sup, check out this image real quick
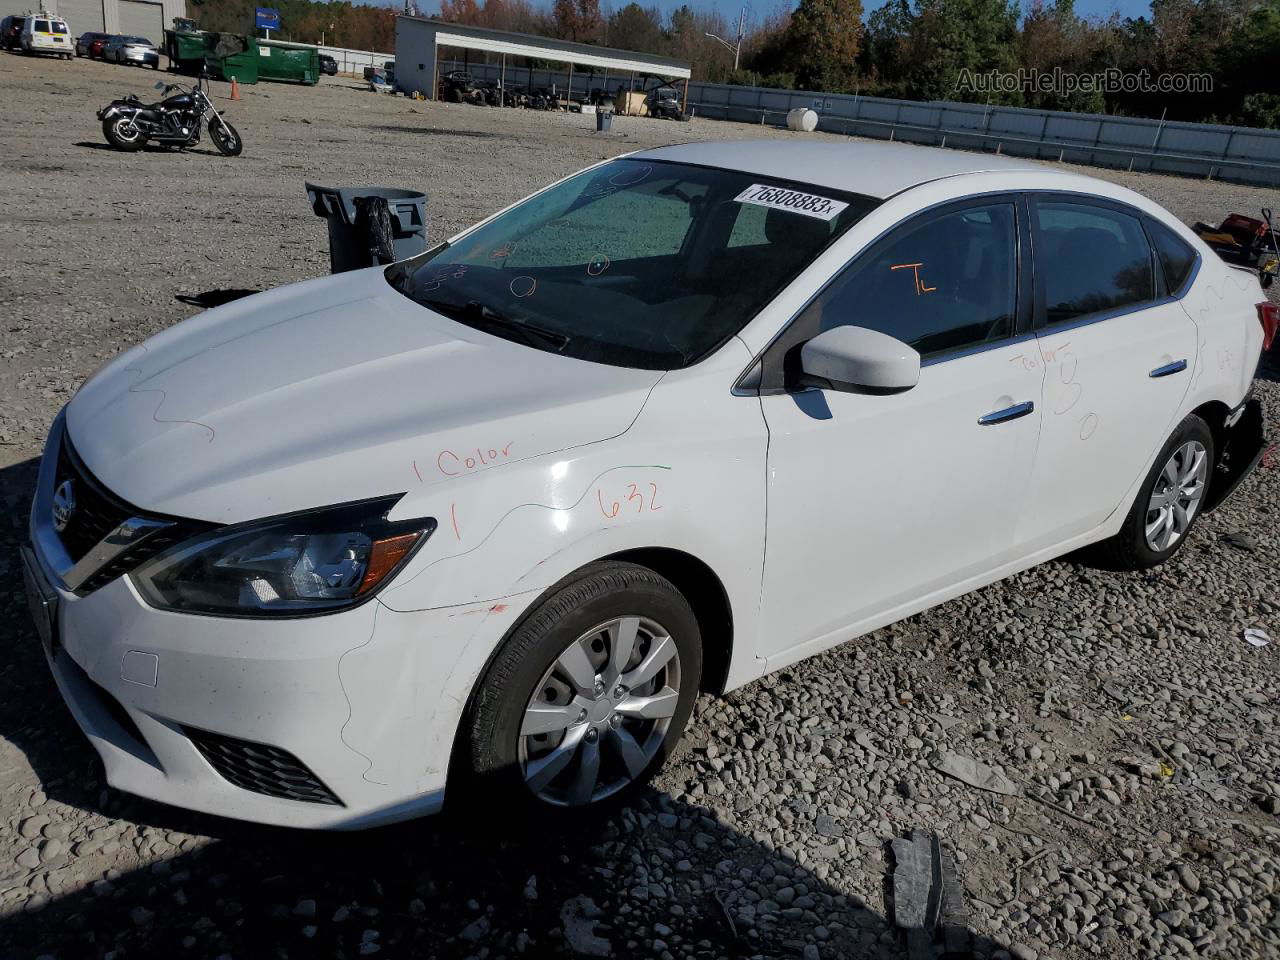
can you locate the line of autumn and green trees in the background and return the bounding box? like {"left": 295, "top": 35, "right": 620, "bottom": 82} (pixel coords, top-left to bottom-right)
{"left": 186, "top": 0, "right": 1280, "bottom": 127}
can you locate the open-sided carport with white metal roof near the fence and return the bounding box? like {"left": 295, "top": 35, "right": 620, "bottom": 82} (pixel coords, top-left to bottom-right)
{"left": 396, "top": 15, "right": 692, "bottom": 102}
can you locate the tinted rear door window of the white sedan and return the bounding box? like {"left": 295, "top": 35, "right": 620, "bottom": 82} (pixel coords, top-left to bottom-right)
{"left": 1036, "top": 201, "right": 1155, "bottom": 324}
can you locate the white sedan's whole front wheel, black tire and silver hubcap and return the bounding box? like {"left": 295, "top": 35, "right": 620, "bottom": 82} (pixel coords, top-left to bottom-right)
{"left": 462, "top": 563, "right": 701, "bottom": 822}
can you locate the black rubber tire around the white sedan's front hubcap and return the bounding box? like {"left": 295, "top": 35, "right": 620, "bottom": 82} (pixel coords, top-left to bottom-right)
{"left": 451, "top": 562, "right": 701, "bottom": 824}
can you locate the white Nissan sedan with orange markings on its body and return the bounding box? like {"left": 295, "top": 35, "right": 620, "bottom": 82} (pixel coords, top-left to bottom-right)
{"left": 24, "top": 141, "right": 1276, "bottom": 827}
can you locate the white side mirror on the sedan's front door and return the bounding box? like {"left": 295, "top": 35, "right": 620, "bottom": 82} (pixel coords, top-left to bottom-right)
{"left": 800, "top": 326, "right": 920, "bottom": 393}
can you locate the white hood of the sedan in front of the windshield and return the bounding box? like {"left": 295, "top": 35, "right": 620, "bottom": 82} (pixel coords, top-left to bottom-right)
{"left": 67, "top": 269, "right": 662, "bottom": 522}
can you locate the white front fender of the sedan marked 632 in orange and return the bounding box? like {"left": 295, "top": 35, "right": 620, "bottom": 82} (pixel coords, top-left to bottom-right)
{"left": 380, "top": 344, "right": 767, "bottom": 691}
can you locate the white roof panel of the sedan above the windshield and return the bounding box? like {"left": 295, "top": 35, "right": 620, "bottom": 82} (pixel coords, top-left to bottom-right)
{"left": 632, "top": 140, "right": 1046, "bottom": 200}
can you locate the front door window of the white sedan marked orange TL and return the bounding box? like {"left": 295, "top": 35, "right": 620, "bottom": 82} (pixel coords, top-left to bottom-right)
{"left": 810, "top": 204, "right": 1018, "bottom": 357}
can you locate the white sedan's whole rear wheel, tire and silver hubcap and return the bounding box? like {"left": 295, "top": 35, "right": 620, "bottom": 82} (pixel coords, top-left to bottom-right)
{"left": 1100, "top": 416, "right": 1215, "bottom": 570}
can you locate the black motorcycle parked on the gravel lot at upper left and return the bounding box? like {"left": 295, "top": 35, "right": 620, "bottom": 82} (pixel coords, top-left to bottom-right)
{"left": 97, "top": 73, "right": 244, "bottom": 156}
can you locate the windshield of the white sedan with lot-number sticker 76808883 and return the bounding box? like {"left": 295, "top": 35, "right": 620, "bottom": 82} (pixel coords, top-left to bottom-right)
{"left": 387, "top": 160, "right": 878, "bottom": 370}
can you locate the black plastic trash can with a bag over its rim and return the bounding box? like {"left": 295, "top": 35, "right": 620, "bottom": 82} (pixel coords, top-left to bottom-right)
{"left": 306, "top": 183, "right": 426, "bottom": 274}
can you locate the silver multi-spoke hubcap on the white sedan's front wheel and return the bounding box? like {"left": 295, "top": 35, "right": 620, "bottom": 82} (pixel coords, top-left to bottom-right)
{"left": 520, "top": 617, "right": 680, "bottom": 806}
